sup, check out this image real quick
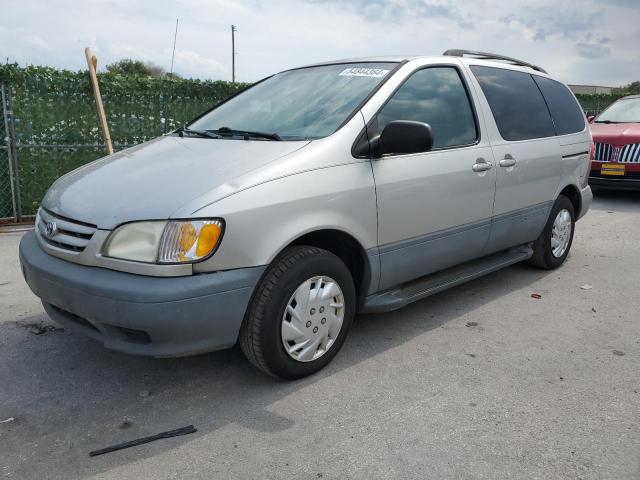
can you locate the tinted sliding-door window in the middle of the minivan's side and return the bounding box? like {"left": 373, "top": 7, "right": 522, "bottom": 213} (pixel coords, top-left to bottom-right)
{"left": 471, "top": 65, "right": 555, "bottom": 141}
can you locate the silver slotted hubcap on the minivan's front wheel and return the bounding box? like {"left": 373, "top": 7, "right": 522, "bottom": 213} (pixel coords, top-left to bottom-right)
{"left": 281, "top": 276, "right": 344, "bottom": 362}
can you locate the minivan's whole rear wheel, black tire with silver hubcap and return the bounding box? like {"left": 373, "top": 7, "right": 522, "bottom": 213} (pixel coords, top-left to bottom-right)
{"left": 529, "top": 195, "right": 576, "bottom": 270}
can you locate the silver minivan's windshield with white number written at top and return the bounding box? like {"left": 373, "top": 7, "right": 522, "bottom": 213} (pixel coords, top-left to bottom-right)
{"left": 189, "top": 63, "right": 396, "bottom": 140}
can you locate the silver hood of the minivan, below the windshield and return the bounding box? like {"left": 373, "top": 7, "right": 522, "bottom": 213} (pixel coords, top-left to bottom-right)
{"left": 42, "top": 136, "right": 309, "bottom": 229}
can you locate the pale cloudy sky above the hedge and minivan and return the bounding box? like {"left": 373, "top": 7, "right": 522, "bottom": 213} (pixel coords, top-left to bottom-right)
{"left": 0, "top": 0, "right": 640, "bottom": 86}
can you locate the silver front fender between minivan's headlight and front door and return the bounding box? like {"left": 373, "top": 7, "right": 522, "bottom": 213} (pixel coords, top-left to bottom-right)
{"left": 194, "top": 161, "right": 377, "bottom": 272}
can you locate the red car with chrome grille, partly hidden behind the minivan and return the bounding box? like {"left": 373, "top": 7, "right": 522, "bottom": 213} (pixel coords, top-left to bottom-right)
{"left": 589, "top": 95, "right": 640, "bottom": 189}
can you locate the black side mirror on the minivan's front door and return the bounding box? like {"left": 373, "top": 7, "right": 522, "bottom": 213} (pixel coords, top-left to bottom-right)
{"left": 374, "top": 120, "right": 433, "bottom": 157}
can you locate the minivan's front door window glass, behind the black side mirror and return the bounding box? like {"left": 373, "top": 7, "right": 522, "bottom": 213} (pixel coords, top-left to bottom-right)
{"left": 378, "top": 67, "right": 477, "bottom": 148}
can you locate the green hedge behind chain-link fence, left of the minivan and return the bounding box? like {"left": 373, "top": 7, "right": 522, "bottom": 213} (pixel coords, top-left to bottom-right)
{"left": 0, "top": 65, "right": 246, "bottom": 217}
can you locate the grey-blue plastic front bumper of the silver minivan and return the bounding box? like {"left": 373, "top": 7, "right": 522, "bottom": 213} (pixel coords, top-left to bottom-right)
{"left": 20, "top": 232, "right": 265, "bottom": 357}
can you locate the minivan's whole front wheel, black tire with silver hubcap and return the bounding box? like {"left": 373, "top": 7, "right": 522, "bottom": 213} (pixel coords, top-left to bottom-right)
{"left": 240, "top": 246, "right": 356, "bottom": 380}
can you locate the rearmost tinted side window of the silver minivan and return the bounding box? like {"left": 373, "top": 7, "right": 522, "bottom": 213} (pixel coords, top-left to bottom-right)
{"left": 533, "top": 75, "right": 585, "bottom": 135}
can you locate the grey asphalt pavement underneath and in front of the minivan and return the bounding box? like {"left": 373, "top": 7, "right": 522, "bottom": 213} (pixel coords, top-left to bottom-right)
{"left": 0, "top": 192, "right": 640, "bottom": 480}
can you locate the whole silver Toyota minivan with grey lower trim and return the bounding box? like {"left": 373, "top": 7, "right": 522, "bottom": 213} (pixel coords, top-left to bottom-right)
{"left": 20, "top": 50, "right": 592, "bottom": 379}
